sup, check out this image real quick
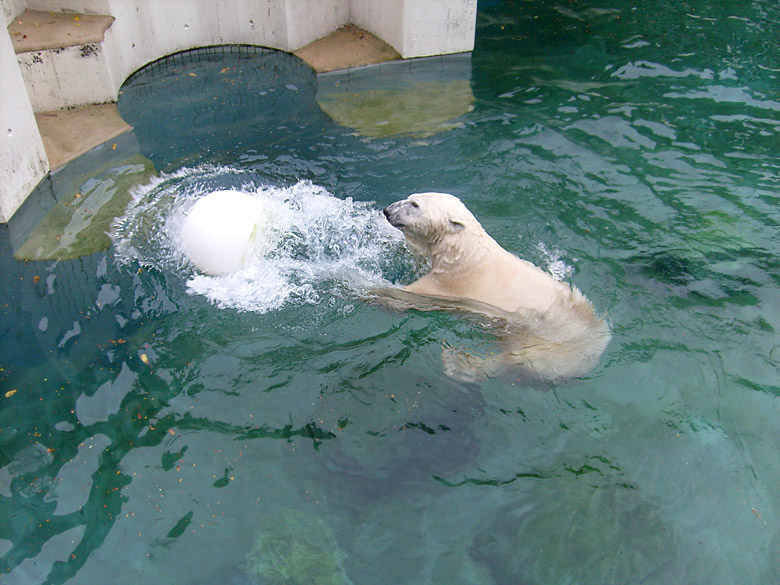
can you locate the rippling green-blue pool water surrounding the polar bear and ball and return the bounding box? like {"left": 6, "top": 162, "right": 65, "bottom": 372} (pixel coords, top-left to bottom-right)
{"left": 0, "top": 1, "right": 780, "bottom": 585}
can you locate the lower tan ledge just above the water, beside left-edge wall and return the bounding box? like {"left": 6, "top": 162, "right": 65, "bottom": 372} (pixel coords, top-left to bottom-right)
{"left": 35, "top": 104, "right": 132, "bottom": 171}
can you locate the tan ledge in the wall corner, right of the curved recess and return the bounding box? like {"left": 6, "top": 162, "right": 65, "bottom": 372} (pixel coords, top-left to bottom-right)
{"left": 293, "top": 24, "right": 401, "bottom": 73}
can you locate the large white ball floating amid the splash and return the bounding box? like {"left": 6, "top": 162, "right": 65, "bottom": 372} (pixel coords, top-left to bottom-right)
{"left": 181, "top": 191, "right": 266, "bottom": 276}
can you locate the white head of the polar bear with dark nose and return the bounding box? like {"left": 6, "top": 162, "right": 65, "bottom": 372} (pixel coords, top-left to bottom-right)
{"left": 384, "top": 193, "right": 486, "bottom": 254}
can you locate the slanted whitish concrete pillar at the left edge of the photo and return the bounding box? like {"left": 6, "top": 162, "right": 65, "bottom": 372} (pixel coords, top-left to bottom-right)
{"left": 0, "top": 27, "right": 49, "bottom": 223}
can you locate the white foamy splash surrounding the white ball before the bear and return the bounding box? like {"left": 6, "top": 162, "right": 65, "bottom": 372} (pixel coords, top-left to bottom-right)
{"left": 112, "top": 167, "right": 416, "bottom": 313}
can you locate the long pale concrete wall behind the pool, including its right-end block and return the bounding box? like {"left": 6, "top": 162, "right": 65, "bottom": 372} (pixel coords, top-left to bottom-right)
{"left": 18, "top": 0, "right": 477, "bottom": 110}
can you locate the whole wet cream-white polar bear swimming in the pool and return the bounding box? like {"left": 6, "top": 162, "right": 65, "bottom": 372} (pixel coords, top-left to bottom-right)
{"left": 384, "top": 193, "right": 611, "bottom": 383}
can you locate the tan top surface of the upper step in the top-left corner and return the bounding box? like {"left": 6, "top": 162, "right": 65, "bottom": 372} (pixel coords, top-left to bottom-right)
{"left": 8, "top": 10, "right": 114, "bottom": 54}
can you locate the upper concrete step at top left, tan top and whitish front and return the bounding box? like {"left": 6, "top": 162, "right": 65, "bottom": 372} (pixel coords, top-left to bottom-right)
{"left": 8, "top": 10, "right": 116, "bottom": 112}
